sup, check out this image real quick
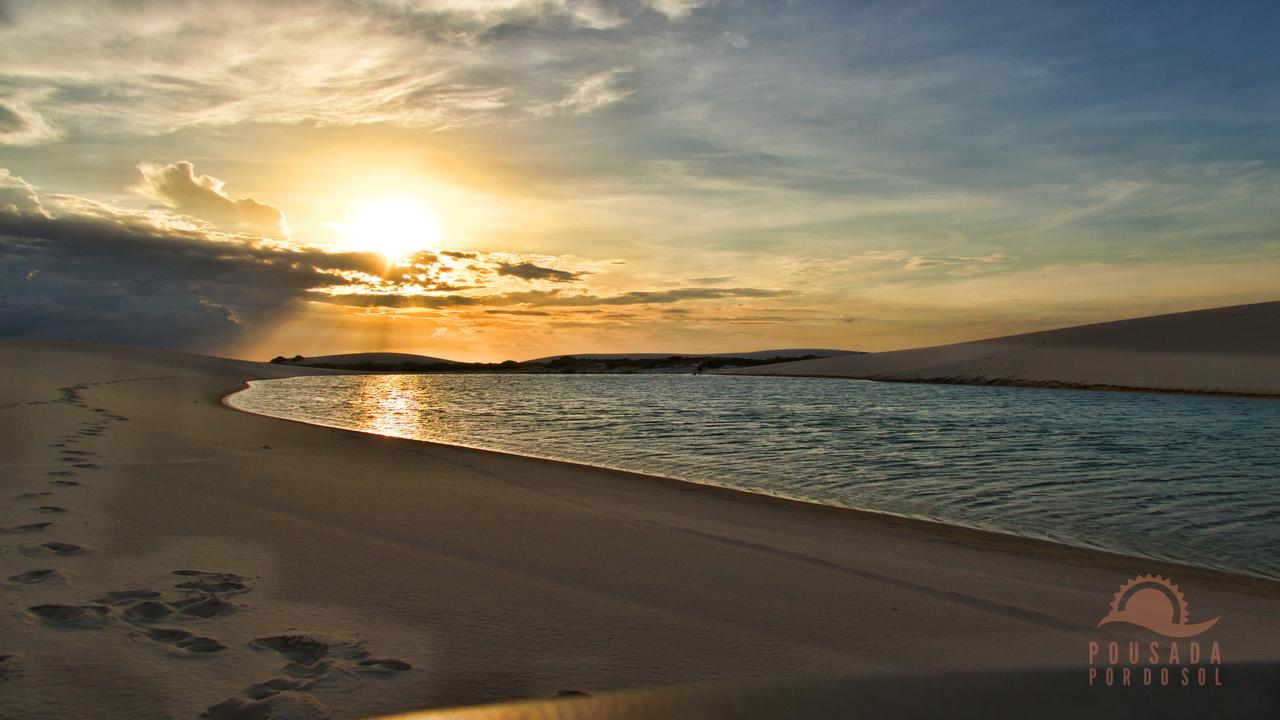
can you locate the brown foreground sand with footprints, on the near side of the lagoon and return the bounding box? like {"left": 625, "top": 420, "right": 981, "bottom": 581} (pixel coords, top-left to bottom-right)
{"left": 0, "top": 342, "right": 1280, "bottom": 719}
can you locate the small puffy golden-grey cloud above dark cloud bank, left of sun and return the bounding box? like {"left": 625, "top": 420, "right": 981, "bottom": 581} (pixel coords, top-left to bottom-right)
{"left": 131, "top": 160, "right": 288, "bottom": 237}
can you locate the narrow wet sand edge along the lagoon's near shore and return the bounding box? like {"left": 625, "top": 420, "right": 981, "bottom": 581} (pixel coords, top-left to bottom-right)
{"left": 220, "top": 381, "right": 1280, "bottom": 589}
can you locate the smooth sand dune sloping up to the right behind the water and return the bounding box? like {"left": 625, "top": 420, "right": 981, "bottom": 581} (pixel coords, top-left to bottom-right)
{"left": 724, "top": 302, "right": 1280, "bottom": 395}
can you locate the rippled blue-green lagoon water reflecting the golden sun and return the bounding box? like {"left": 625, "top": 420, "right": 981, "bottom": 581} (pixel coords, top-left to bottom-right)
{"left": 230, "top": 375, "right": 1280, "bottom": 578}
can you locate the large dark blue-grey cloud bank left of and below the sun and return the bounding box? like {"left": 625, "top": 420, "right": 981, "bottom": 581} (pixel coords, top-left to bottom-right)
{"left": 0, "top": 181, "right": 383, "bottom": 348}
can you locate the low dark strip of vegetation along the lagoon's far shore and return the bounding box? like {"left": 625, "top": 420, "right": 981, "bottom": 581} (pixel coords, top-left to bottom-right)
{"left": 271, "top": 355, "right": 820, "bottom": 375}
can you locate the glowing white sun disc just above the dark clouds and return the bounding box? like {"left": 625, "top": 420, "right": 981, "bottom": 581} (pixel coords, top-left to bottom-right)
{"left": 333, "top": 197, "right": 440, "bottom": 264}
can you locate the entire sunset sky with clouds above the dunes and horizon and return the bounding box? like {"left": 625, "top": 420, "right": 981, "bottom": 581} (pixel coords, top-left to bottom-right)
{"left": 0, "top": 0, "right": 1280, "bottom": 361}
